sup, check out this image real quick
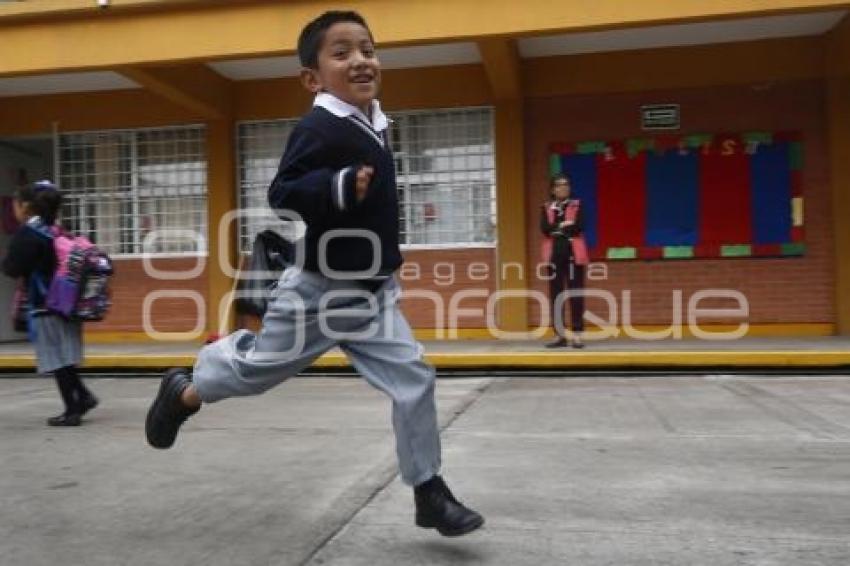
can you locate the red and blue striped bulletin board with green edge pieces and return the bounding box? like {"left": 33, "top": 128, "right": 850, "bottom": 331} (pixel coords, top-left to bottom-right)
{"left": 549, "top": 132, "right": 805, "bottom": 260}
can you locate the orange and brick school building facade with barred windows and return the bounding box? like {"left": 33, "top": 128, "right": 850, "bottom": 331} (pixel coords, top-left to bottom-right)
{"left": 0, "top": 0, "right": 850, "bottom": 340}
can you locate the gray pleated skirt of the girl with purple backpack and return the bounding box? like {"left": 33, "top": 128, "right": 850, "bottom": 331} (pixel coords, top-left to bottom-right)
{"left": 31, "top": 314, "right": 83, "bottom": 373}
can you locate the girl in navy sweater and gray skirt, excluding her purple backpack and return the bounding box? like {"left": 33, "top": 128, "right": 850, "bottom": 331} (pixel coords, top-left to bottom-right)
{"left": 3, "top": 181, "right": 98, "bottom": 426}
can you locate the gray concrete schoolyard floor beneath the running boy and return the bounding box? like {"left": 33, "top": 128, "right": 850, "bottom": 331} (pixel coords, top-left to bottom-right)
{"left": 0, "top": 376, "right": 850, "bottom": 566}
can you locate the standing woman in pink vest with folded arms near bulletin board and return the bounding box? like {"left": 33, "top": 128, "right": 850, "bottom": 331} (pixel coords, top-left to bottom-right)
{"left": 540, "top": 175, "right": 588, "bottom": 348}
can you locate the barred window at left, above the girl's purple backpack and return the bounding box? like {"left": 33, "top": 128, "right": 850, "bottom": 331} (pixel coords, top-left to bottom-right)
{"left": 59, "top": 126, "right": 207, "bottom": 255}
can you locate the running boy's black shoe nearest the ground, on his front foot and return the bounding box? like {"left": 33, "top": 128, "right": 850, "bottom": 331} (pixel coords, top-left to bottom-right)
{"left": 413, "top": 476, "right": 484, "bottom": 537}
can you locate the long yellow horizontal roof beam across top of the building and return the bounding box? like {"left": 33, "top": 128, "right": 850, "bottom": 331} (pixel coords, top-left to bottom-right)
{"left": 0, "top": 0, "right": 850, "bottom": 76}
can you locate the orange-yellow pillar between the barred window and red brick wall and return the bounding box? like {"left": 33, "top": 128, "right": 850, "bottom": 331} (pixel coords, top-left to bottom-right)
{"left": 494, "top": 99, "right": 528, "bottom": 332}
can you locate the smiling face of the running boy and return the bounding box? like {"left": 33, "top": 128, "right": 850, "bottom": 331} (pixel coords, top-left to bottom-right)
{"left": 301, "top": 22, "right": 381, "bottom": 112}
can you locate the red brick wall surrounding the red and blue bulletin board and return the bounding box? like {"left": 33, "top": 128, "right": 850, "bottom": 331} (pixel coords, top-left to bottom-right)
{"left": 526, "top": 82, "right": 835, "bottom": 324}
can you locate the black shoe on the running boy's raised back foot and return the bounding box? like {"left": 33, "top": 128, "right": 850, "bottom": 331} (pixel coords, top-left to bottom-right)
{"left": 145, "top": 368, "right": 198, "bottom": 448}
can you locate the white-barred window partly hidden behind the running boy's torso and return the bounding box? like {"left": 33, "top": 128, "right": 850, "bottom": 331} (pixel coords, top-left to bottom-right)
{"left": 239, "top": 108, "right": 496, "bottom": 252}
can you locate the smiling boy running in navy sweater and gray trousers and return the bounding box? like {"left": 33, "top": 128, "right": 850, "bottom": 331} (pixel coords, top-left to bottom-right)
{"left": 145, "top": 12, "right": 484, "bottom": 536}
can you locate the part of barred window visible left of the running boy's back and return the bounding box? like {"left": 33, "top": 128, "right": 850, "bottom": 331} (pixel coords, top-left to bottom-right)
{"left": 238, "top": 120, "right": 304, "bottom": 252}
